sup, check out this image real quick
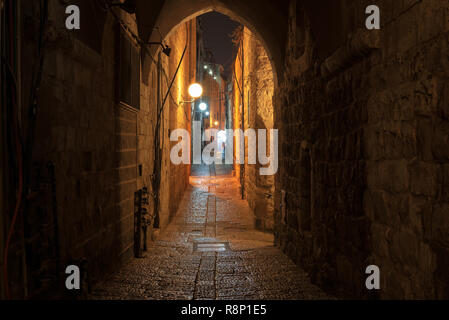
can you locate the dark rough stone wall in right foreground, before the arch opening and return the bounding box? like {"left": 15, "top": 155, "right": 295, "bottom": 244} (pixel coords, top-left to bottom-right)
{"left": 275, "top": 0, "right": 449, "bottom": 298}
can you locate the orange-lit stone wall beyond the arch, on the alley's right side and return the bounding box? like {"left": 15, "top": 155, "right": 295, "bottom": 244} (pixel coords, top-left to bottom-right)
{"left": 233, "top": 27, "right": 274, "bottom": 231}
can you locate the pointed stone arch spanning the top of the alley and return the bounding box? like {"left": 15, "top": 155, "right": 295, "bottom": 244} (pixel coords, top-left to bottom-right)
{"left": 136, "top": 0, "right": 288, "bottom": 87}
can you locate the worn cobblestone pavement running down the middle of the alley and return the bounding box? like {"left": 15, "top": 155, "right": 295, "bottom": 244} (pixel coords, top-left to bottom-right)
{"left": 91, "top": 166, "right": 329, "bottom": 300}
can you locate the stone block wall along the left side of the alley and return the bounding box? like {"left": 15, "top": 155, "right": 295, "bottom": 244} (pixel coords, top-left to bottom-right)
{"left": 2, "top": 0, "right": 196, "bottom": 296}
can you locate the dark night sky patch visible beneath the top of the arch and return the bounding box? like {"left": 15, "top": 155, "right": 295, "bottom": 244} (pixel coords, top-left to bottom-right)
{"left": 200, "top": 12, "right": 240, "bottom": 73}
